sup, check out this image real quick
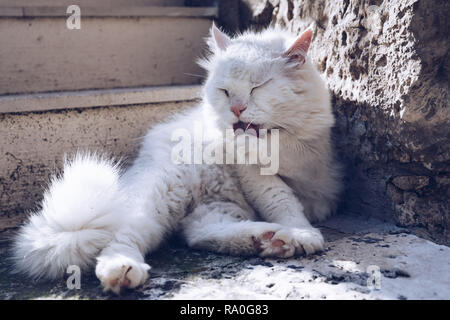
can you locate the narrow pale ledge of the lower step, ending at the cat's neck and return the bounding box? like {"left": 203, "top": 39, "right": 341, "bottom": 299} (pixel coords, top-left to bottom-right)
{"left": 0, "top": 85, "right": 201, "bottom": 113}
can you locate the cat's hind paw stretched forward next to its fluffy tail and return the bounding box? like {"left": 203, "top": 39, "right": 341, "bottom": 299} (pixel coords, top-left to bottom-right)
{"left": 95, "top": 255, "right": 150, "bottom": 294}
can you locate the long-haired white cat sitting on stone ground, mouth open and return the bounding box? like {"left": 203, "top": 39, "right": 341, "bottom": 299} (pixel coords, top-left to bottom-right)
{"left": 14, "top": 25, "right": 340, "bottom": 293}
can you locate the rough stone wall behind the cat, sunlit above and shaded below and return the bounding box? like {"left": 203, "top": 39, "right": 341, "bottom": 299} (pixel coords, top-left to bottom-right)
{"left": 237, "top": 0, "right": 450, "bottom": 244}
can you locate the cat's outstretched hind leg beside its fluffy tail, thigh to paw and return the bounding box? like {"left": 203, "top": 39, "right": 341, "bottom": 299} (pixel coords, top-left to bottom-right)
{"left": 95, "top": 168, "right": 192, "bottom": 294}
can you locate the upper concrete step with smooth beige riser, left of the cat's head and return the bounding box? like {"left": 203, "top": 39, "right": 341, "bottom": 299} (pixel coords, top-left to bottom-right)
{"left": 0, "top": 5, "right": 217, "bottom": 95}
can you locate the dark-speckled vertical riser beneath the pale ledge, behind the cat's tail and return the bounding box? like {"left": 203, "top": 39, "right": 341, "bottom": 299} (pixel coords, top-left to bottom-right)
{"left": 0, "top": 101, "right": 194, "bottom": 232}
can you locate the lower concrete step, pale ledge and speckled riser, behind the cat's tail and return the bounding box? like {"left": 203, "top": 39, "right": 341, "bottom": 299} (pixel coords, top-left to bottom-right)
{"left": 0, "top": 85, "right": 201, "bottom": 228}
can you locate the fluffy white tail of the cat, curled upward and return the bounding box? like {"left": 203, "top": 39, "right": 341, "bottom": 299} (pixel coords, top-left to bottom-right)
{"left": 13, "top": 154, "right": 121, "bottom": 279}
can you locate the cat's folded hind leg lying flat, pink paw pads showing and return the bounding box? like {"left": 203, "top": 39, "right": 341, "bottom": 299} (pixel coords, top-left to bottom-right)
{"left": 181, "top": 202, "right": 295, "bottom": 258}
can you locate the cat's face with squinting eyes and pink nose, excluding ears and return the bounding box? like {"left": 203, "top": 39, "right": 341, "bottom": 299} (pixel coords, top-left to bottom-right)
{"left": 205, "top": 48, "right": 286, "bottom": 128}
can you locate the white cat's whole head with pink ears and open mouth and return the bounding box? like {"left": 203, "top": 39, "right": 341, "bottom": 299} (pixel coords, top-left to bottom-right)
{"left": 200, "top": 25, "right": 334, "bottom": 138}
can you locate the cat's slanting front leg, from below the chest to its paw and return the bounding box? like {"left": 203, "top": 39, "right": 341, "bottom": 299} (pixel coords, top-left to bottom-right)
{"left": 239, "top": 166, "right": 324, "bottom": 254}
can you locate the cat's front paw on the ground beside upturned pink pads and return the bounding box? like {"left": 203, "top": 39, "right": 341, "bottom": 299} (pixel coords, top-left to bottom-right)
{"left": 273, "top": 228, "right": 325, "bottom": 255}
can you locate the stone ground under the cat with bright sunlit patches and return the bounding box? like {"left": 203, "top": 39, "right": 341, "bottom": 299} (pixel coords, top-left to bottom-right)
{"left": 0, "top": 215, "right": 450, "bottom": 300}
